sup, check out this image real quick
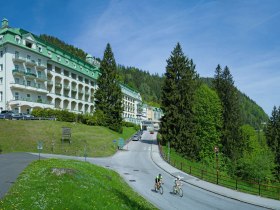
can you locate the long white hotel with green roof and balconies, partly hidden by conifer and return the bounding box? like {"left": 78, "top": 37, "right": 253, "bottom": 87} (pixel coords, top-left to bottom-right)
{"left": 0, "top": 19, "right": 142, "bottom": 123}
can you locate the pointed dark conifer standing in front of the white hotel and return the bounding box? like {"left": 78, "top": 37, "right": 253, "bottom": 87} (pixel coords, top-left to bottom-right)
{"left": 95, "top": 43, "right": 123, "bottom": 132}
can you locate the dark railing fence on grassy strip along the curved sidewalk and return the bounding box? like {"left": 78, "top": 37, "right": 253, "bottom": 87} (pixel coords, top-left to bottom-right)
{"left": 159, "top": 143, "right": 280, "bottom": 200}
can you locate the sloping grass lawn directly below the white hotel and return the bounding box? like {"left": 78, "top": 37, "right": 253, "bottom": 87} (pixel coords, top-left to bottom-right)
{"left": 0, "top": 120, "right": 136, "bottom": 157}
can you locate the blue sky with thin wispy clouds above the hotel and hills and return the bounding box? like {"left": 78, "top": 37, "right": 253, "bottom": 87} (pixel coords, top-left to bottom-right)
{"left": 0, "top": 0, "right": 280, "bottom": 115}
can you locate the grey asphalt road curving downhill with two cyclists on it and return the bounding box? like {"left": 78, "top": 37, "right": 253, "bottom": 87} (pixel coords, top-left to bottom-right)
{"left": 89, "top": 132, "right": 262, "bottom": 210}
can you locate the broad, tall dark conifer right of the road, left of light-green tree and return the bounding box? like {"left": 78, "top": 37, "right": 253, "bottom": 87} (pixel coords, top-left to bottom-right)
{"left": 161, "top": 43, "right": 197, "bottom": 158}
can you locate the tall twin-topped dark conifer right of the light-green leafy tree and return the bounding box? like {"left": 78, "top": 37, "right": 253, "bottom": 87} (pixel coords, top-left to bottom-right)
{"left": 214, "top": 65, "right": 243, "bottom": 160}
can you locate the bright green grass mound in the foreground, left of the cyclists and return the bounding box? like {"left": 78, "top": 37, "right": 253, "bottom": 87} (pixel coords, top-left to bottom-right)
{"left": 0, "top": 159, "right": 156, "bottom": 210}
